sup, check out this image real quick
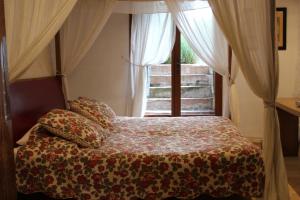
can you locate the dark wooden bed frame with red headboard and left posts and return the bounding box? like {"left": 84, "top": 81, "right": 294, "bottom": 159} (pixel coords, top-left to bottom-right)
{"left": 0, "top": 0, "right": 245, "bottom": 200}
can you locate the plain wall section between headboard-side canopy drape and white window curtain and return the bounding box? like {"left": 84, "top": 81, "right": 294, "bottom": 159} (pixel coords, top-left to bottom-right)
{"left": 69, "top": 14, "right": 129, "bottom": 115}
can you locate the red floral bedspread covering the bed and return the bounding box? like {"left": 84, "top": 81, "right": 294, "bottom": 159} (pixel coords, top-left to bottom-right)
{"left": 16, "top": 117, "right": 264, "bottom": 200}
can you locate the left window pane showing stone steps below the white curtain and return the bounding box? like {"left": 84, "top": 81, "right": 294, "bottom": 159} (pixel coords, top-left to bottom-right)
{"left": 146, "top": 62, "right": 171, "bottom": 115}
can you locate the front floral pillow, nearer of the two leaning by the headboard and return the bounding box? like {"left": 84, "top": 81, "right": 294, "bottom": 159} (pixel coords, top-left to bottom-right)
{"left": 38, "top": 109, "right": 107, "bottom": 148}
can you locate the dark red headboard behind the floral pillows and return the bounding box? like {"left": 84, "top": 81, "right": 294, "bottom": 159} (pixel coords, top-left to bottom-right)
{"left": 9, "top": 77, "right": 66, "bottom": 142}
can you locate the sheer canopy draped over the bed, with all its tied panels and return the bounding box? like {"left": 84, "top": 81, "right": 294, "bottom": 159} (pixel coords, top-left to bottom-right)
{"left": 1, "top": 0, "right": 289, "bottom": 200}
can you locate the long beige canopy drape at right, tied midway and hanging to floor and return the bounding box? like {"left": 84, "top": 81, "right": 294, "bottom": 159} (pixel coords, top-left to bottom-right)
{"left": 209, "top": 0, "right": 289, "bottom": 200}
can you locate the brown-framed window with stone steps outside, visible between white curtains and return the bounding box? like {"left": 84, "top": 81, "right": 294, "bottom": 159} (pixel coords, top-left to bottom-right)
{"left": 145, "top": 29, "right": 222, "bottom": 116}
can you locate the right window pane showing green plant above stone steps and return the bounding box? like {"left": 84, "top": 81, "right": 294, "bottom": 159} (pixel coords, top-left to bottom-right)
{"left": 181, "top": 35, "right": 214, "bottom": 115}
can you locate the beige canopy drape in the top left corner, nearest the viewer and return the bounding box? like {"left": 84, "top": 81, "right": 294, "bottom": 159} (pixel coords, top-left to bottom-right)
{"left": 4, "top": 0, "right": 77, "bottom": 81}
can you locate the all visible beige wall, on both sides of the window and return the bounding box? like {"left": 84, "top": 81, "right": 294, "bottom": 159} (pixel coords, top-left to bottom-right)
{"left": 70, "top": 0, "right": 300, "bottom": 137}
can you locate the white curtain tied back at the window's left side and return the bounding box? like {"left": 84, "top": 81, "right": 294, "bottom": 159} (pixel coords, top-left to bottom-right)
{"left": 130, "top": 13, "right": 176, "bottom": 117}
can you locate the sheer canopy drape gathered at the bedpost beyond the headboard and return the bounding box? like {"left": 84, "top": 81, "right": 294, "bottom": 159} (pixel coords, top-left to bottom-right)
{"left": 60, "top": 0, "right": 116, "bottom": 99}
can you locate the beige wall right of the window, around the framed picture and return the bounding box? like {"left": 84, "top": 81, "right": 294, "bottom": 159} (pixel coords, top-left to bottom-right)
{"left": 237, "top": 0, "right": 300, "bottom": 137}
